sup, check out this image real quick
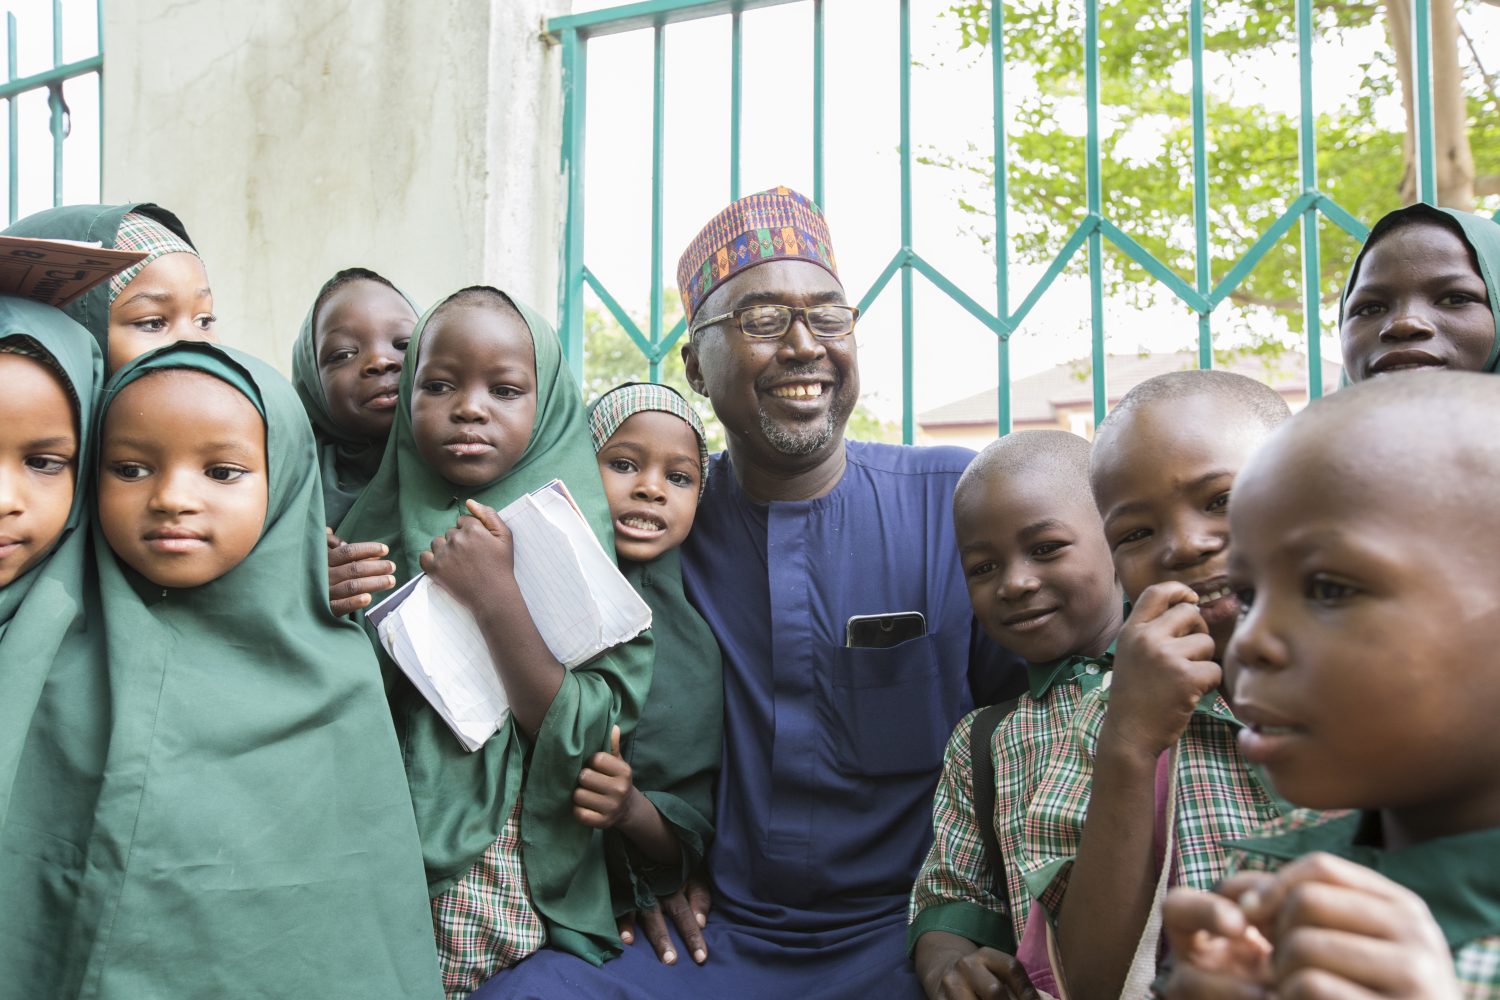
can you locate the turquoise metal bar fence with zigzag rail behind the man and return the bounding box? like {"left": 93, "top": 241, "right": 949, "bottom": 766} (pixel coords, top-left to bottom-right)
{"left": 548, "top": 0, "right": 1437, "bottom": 444}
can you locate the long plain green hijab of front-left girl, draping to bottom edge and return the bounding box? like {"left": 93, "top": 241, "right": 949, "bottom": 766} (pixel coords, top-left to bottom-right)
{"left": 66, "top": 343, "right": 441, "bottom": 999}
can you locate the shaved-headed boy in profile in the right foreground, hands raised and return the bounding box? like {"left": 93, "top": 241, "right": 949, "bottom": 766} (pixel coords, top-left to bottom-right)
{"left": 1166, "top": 372, "right": 1500, "bottom": 1000}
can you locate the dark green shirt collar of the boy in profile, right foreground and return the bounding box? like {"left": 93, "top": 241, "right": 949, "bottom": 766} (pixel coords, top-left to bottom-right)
{"left": 1230, "top": 813, "right": 1500, "bottom": 951}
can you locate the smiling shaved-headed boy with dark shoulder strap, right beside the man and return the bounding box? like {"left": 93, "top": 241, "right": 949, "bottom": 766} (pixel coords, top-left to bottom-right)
{"left": 908, "top": 430, "right": 1125, "bottom": 1000}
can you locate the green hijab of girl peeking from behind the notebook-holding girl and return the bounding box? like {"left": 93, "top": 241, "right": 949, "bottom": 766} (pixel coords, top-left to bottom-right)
{"left": 291, "top": 268, "right": 420, "bottom": 526}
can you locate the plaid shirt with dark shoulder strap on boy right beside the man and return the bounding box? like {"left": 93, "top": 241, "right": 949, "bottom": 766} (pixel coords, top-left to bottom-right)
{"left": 906, "top": 648, "right": 1113, "bottom": 955}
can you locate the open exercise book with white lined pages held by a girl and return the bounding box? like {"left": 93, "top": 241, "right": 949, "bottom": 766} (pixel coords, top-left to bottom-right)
{"left": 368, "top": 480, "right": 651, "bottom": 751}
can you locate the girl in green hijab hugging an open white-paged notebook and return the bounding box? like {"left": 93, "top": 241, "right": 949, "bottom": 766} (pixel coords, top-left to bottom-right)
{"left": 338, "top": 286, "right": 653, "bottom": 997}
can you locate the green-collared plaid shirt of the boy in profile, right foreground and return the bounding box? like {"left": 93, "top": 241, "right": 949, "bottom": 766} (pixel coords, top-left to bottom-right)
{"left": 1232, "top": 810, "right": 1500, "bottom": 1000}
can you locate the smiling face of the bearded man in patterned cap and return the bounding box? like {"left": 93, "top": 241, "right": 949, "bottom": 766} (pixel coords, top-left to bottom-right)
{"left": 683, "top": 259, "right": 860, "bottom": 465}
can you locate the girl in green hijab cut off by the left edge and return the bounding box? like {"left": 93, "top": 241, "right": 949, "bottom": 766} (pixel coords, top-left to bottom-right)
{"left": 0, "top": 297, "right": 108, "bottom": 997}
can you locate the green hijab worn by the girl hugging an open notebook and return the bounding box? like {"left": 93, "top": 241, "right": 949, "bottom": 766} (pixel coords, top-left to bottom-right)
{"left": 338, "top": 289, "right": 653, "bottom": 964}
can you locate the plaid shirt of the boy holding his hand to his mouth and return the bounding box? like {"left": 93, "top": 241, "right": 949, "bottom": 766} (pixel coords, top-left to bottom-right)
{"left": 1022, "top": 675, "right": 1290, "bottom": 919}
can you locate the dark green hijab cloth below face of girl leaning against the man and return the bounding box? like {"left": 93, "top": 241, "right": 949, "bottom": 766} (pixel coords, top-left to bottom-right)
{"left": 608, "top": 549, "right": 725, "bottom": 913}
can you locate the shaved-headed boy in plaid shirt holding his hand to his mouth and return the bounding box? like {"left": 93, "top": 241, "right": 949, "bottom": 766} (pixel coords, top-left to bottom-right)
{"left": 1023, "top": 372, "right": 1314, "bottom": 1000}
